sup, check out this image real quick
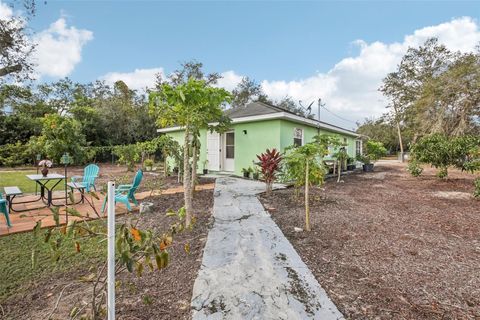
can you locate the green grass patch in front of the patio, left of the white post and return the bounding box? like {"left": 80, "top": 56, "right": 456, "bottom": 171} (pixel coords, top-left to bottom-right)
{"left": 0, "top": 222, "right": 107, "bottom": 304}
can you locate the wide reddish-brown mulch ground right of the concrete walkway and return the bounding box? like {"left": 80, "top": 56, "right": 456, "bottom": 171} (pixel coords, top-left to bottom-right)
{"left": 260, "top": 162, "right": 480, "bottom": 319}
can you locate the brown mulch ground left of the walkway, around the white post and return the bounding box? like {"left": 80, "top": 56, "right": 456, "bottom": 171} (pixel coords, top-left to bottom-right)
{"left": 0, "top": 190, "right": 213, "bottom": 319}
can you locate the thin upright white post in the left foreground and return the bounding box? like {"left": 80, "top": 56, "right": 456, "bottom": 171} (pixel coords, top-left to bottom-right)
{"left": 107, "top": 181, "right": 115, "bottom": 320}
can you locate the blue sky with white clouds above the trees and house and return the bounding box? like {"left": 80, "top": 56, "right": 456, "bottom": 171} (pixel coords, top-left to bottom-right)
{"left": 12, "top": 1, "right": 480, "bottom": 126}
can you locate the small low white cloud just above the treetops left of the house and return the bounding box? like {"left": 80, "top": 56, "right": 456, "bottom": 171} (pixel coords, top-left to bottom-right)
{"left": 100, "top": 68, "right": 165, "bottom": 90}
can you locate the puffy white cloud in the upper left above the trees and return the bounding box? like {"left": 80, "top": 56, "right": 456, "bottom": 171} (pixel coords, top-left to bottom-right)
{"left": 33, "top": 17, "right": 93, "bottom": 77}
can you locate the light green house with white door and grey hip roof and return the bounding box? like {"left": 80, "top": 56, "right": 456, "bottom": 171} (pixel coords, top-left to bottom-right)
{"left": 157, "top": 102, "right": 362, "bottom": 175}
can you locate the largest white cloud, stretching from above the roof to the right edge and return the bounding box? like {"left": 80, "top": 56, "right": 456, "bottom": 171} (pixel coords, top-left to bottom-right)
{"left": 262, "top": 17, "right": 480, "bottom": 126}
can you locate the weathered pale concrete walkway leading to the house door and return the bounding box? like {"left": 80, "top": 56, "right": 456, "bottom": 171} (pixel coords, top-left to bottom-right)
{"left": 192, "top": 177, "right": 343, "bottom": 320}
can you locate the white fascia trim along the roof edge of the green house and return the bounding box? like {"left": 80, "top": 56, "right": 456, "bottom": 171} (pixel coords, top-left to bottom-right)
{"left": 157, "top": 112, "right": 360, "bottom": 137}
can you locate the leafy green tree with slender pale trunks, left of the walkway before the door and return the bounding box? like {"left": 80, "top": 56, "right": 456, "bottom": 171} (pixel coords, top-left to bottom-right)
{"left": 149, "top": 78, "right": 230, "bottom": 225}
